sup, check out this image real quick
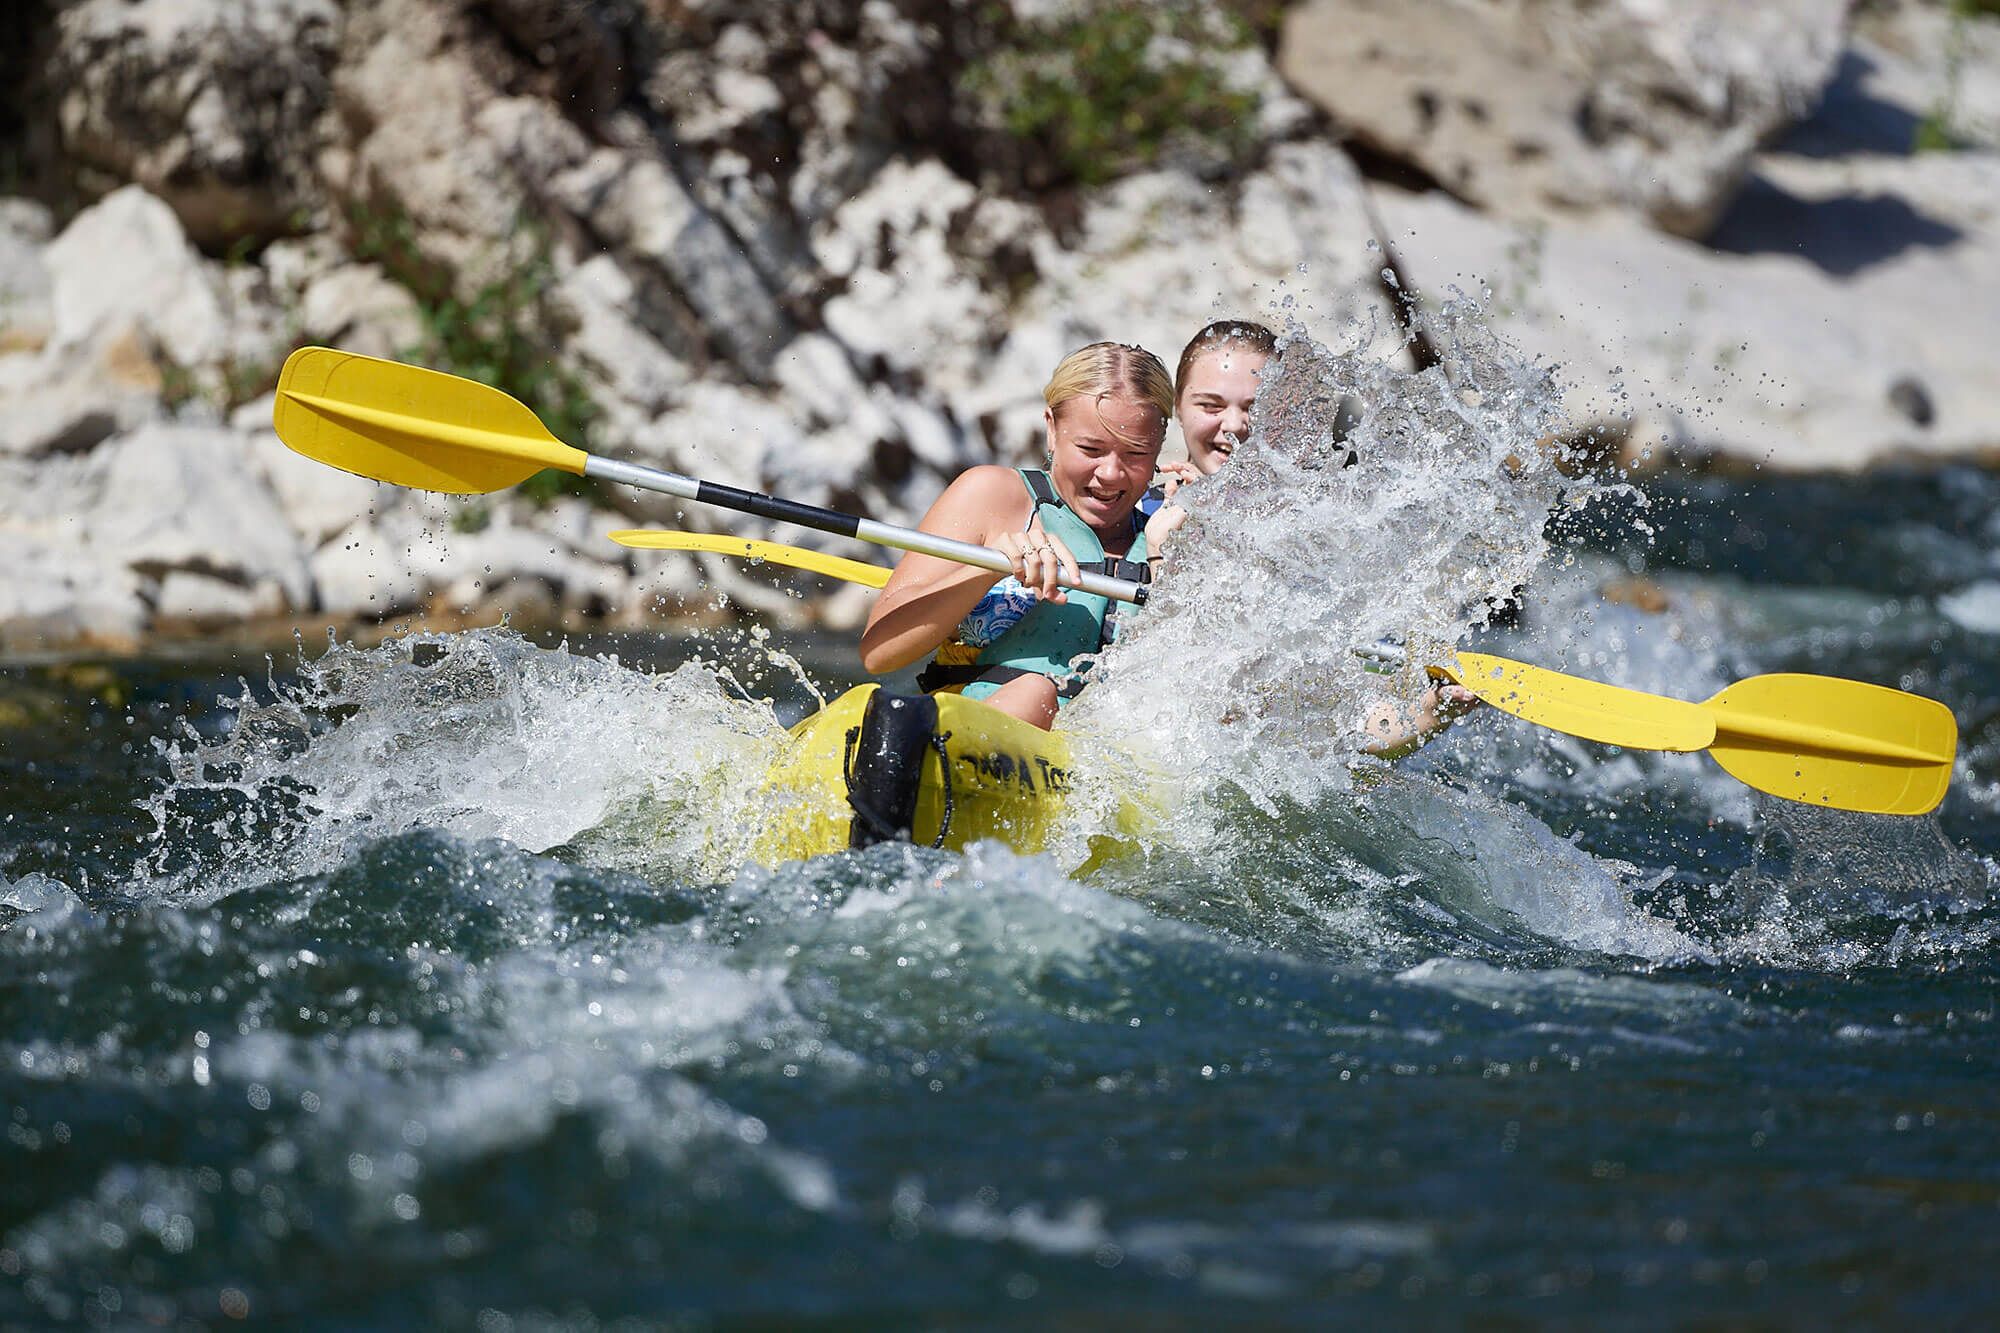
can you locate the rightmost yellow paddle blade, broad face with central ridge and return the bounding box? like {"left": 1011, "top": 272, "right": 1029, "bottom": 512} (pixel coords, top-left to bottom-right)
{"left": 1702, "top": 673, "right": 1958, "bottom": 815}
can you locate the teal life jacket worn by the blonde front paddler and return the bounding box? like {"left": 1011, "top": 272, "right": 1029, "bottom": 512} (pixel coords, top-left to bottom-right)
{"left": 916, "top": 468, "right": 1152, "bottom": 703}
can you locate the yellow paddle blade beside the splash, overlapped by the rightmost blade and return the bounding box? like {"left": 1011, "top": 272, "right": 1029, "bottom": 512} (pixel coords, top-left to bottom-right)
{"left": 1456, "top": 652, "right": 1716, "bottom": 751}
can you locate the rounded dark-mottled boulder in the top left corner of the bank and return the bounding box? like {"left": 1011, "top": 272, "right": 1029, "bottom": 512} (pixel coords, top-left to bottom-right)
{"left": 52, "top": 0, "right": 340, "bottom": 250}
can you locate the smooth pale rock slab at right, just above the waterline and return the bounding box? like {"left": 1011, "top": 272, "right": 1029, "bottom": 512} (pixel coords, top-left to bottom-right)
{"left": 1376, "top": 154, "right": 2000, "bottom": 470}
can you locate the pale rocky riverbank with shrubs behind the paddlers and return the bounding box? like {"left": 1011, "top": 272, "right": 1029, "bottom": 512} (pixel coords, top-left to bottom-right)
{"left": 0, "top": 0, "right": 2000, "bottom": 652}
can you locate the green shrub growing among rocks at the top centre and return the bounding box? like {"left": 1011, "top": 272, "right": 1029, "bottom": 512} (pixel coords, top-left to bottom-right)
{"left": 958, "top": 0, "right": 1258, "bottom": 186}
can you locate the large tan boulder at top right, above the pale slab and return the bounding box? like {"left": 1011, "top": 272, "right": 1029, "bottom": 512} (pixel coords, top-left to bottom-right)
{"left": 1278, "top": 0, "right": 1848, "bottom": 236}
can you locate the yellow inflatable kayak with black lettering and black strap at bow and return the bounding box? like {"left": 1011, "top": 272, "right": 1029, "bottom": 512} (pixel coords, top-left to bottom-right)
{"left": 756, "top": 685, "right": 1140, "bottom": 865}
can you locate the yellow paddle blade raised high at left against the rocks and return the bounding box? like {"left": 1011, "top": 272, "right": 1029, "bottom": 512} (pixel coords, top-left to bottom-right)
{"left": 272, "top": 346, "right": 588, "bottom": 494}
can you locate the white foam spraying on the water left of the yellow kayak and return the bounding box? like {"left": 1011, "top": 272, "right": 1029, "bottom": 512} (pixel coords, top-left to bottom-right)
{"left": 150, "top": 628, "right": 784, "bottom": 895}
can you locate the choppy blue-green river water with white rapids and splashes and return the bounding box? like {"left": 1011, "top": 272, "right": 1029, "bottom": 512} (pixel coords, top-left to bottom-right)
{"left": 0, "top": 320, "right": 2000, "bottom": 1329}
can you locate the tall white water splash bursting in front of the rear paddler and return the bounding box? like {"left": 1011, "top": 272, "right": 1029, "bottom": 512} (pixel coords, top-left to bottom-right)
{"left": 1064, "top": 302, "right": 1570, "bottom": 809}
